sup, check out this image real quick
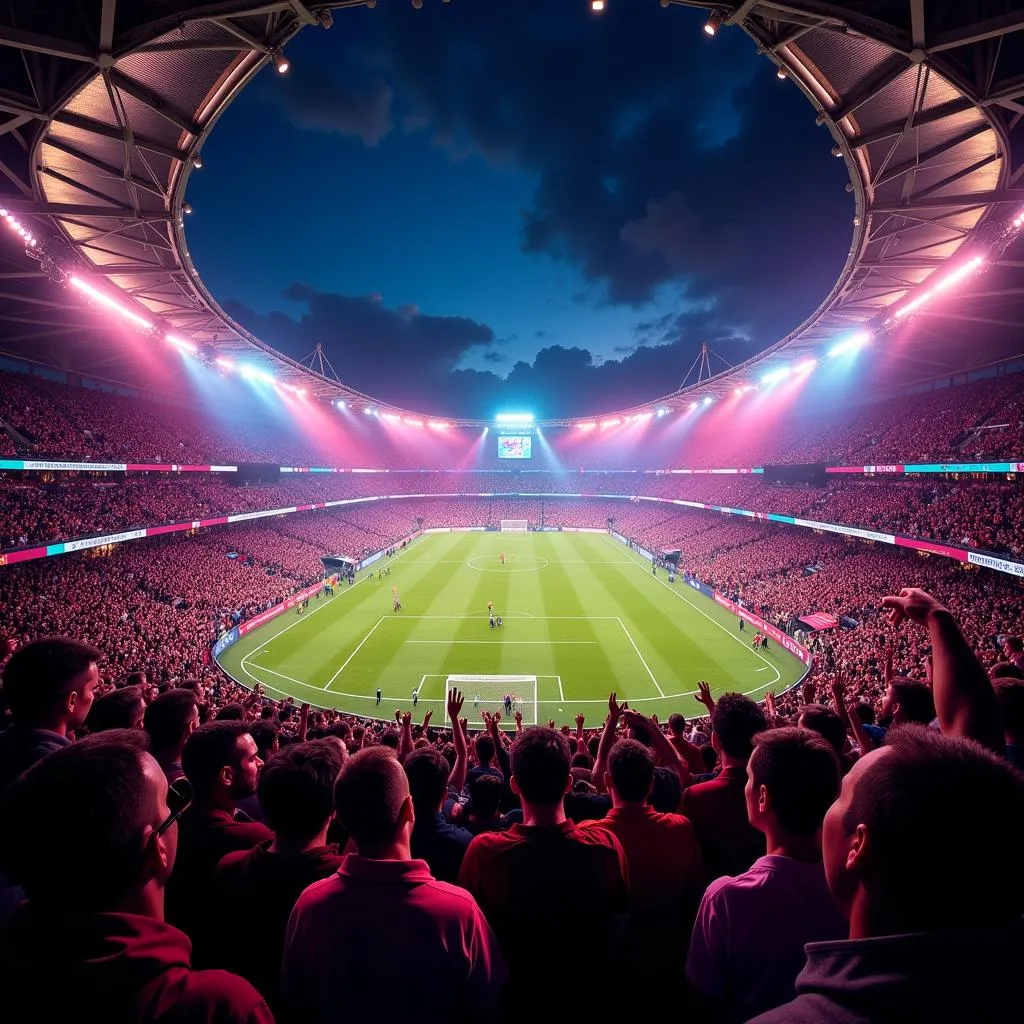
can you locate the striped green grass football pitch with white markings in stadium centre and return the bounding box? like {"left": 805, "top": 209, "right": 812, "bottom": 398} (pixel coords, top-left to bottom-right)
{"left": 220, "top": 534, "right": 803, "bottom": 725}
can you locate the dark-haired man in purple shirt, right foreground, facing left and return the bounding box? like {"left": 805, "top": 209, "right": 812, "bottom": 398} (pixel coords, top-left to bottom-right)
{"left": 686, "top": 728, "right": 846, "bottom": 1024}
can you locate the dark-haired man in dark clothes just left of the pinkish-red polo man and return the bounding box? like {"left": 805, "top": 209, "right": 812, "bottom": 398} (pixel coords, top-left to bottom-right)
{"left": 208, "top": 739, "right": 343, "bottom": 1013}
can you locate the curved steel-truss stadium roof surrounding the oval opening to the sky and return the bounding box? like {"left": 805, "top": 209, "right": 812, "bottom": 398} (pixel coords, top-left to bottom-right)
{"left": 0, "top": 0, "right": 1024, "bottom": 421}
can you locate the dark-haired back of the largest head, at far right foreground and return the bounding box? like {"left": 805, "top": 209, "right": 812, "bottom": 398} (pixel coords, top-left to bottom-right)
{"left": 839, "top": 726, "right": 1024, "bottom": 931}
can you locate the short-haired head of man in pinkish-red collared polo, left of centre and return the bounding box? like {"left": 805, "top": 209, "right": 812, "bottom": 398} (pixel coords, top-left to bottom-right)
{"left": 334, "top": 746, "right": 410, "bottom": 851}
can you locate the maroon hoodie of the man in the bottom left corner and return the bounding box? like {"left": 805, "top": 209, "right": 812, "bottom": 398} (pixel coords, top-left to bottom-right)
{"left": 0, "top": 905, "right": 273, "bottom": 1024}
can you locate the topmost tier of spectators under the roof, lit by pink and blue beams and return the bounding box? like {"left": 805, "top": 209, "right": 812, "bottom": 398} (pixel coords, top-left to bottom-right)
{"left": 0, "top": 364, "right": 1024, "bottom": 472}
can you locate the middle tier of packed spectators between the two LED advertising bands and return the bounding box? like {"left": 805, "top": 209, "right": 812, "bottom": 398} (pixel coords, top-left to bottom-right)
{"left": 6, "top": 473, "right": 1024, "bottom": 555}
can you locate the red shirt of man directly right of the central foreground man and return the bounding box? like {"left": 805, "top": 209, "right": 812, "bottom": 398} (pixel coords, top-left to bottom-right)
{"left": 580, "top": 804, "right": 705, "bottom": 968}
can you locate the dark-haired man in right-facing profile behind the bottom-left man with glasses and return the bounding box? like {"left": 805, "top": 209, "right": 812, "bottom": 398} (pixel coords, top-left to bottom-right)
{"left": 167, "top": 721, "right": 272, "bottom": 942}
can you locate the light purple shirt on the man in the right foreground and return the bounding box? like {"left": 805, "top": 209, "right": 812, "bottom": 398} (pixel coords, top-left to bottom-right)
{"left": 686, "top": 855, "right": 848, "bottom": 1024}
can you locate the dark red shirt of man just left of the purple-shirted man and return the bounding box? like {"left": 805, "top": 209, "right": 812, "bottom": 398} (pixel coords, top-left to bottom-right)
{"left": 679, "top": 768, "right": 766, "bottom": 880}
